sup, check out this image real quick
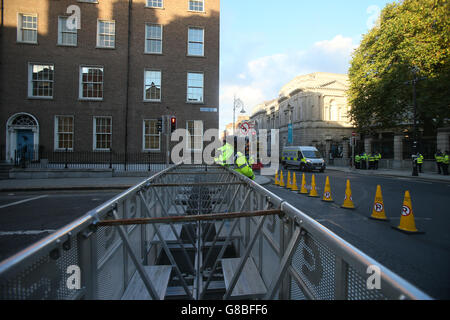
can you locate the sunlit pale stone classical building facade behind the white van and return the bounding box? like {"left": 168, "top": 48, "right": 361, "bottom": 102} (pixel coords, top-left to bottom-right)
{"left": 250, "top": 72, "right": 353, "bottom": 159}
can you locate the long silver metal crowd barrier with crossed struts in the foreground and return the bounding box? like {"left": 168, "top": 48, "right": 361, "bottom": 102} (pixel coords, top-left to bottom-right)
{"left": 0, "top": 165, "right": 430, "bottom": 300}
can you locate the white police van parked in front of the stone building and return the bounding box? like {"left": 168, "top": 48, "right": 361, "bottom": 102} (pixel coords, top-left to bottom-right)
{"left": 281, "top": 146, "right": 326, "bottom": 172}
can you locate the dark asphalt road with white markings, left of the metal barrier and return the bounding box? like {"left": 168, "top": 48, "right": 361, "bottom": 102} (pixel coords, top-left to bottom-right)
{"left": 0, "top": 191, "right": 120, "bottom": 261}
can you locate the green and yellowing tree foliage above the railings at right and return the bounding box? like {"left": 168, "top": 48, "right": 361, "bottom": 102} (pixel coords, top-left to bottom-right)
{"left": 348, "top": 0, "right": 450, "bottom": 132}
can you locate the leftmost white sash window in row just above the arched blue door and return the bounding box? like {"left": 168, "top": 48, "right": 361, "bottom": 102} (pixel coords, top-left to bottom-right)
{"left": 28, "top": 63, "right": 54, "bottom": 98}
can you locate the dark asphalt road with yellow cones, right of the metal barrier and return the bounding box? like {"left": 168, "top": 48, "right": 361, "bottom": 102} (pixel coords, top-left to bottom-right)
{"left": 265, "top": 170, "right": 450, "bottom": 299}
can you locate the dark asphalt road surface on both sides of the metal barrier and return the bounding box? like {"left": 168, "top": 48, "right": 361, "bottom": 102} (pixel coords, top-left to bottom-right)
{"left": 0, "top": 170, "right": 450, "bottom": 299}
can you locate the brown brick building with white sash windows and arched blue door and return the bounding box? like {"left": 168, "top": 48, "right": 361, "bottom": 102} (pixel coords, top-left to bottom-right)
{"left": 0, "top": 0, "right": 220, "bottom": 162}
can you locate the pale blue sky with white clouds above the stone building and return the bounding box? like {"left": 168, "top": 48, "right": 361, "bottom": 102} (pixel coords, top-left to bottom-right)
{"left": 219, "top": 0, "right": 394, "bottom": 130}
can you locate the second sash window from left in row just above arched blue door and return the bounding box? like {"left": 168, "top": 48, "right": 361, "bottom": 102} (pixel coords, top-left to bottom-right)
{"left": 80, "top": 67, "right": 103, "bottom": 100}
